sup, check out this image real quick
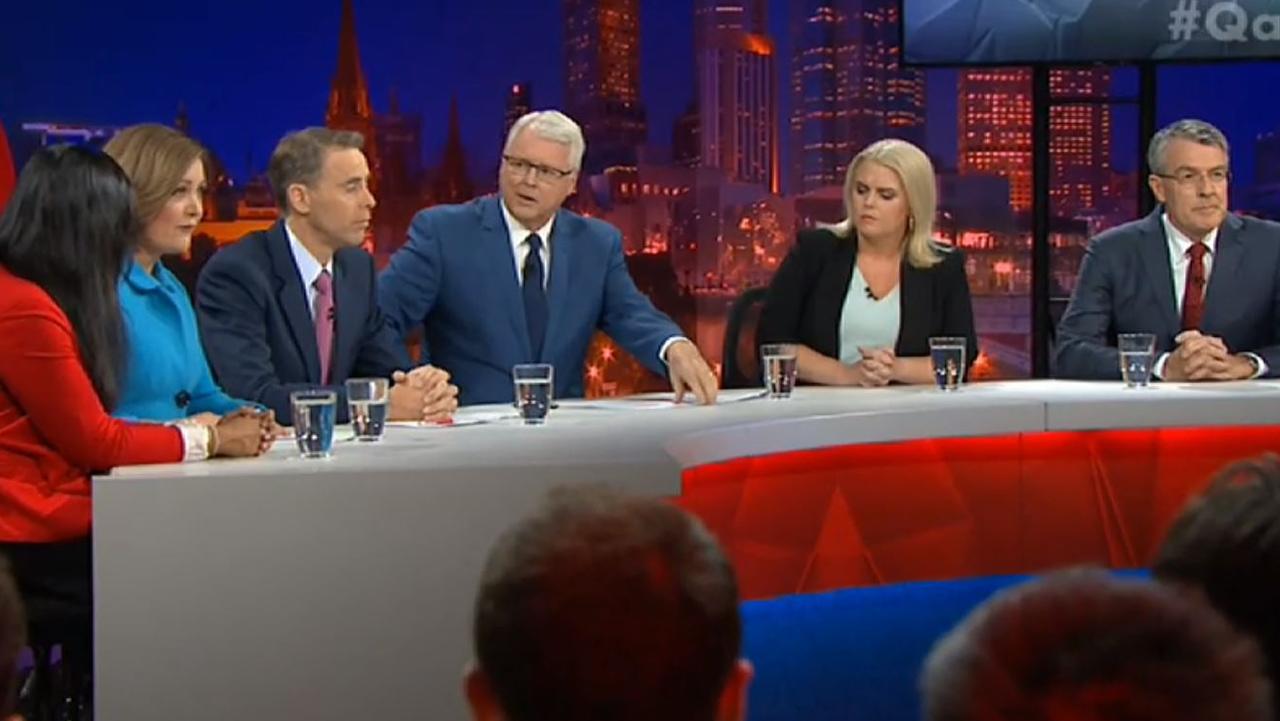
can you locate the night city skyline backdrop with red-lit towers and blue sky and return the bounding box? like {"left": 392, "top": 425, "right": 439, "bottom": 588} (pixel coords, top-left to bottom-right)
{"left": 0, "top": 0, "right": 1280, "bottom": 393}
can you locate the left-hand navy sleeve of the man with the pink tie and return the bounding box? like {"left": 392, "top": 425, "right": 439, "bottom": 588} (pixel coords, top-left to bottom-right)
{"left": 196, "top": 252, "right": 347, "bottom": 425}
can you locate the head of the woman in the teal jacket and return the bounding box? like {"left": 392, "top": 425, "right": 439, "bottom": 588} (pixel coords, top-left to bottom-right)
{"left": 102, "top": 124, "right": 205, "bottom": 270}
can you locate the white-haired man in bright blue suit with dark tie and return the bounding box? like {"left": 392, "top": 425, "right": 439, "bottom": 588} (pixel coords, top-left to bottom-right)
{"left": 378, "top": 110, "right": 717, "bottom": 405}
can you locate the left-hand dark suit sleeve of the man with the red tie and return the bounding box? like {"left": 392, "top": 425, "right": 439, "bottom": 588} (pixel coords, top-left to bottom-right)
{"left": 1053, "top": 241, "right": 1120, "bottom": 380}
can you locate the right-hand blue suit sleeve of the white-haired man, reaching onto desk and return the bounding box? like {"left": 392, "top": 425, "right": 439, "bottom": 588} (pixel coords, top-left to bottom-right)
{"left": 600, "top": 228, "right": 684, "bottom": 375}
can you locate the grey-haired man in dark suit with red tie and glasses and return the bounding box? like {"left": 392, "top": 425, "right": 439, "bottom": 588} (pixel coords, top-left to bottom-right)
{"left": 1056, "top": 120, "right": 1280, "bottom": 380}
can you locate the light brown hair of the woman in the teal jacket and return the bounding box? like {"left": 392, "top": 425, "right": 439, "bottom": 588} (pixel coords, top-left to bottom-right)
{"left": 102, "top": 123, "right": 205, "bottom": 224}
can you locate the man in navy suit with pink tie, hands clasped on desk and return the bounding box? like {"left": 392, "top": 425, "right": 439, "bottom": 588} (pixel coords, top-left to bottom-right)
{"left": 196, "top": 128, "right": 457, "bottom": 423}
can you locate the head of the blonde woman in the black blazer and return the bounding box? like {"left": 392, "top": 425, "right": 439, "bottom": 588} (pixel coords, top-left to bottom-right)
{"left": 832, "top": 140, "right": 941, "bottom": 268}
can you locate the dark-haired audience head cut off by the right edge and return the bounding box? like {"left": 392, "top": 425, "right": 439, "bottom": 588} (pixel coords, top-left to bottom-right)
{"left": 1152, "top": 456, "right": 1280, "bottom": 701}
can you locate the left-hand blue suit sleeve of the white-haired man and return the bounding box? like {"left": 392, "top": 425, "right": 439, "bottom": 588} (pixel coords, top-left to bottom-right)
{"left": 376, "top": 211, "right": 440, "bottom": 364}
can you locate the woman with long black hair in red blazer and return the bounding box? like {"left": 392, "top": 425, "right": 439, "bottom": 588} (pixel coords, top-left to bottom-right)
{"left": 0, "top": 146, "right": 270, "bottom": 607}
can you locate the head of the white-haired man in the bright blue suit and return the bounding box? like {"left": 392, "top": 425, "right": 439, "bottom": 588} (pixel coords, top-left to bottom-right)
{"left": 498, "top": 110, "right": 586, "bottom": 231}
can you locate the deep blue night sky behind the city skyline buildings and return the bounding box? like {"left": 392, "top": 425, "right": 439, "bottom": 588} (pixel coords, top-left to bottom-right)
{"left": 0, "top": 0, "right": 1280, "bottom": 184}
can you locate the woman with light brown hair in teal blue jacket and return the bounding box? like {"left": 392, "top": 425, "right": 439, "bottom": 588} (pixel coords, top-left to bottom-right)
{"left": 104, "top": 124, "right": 253, "bottom": 424}
